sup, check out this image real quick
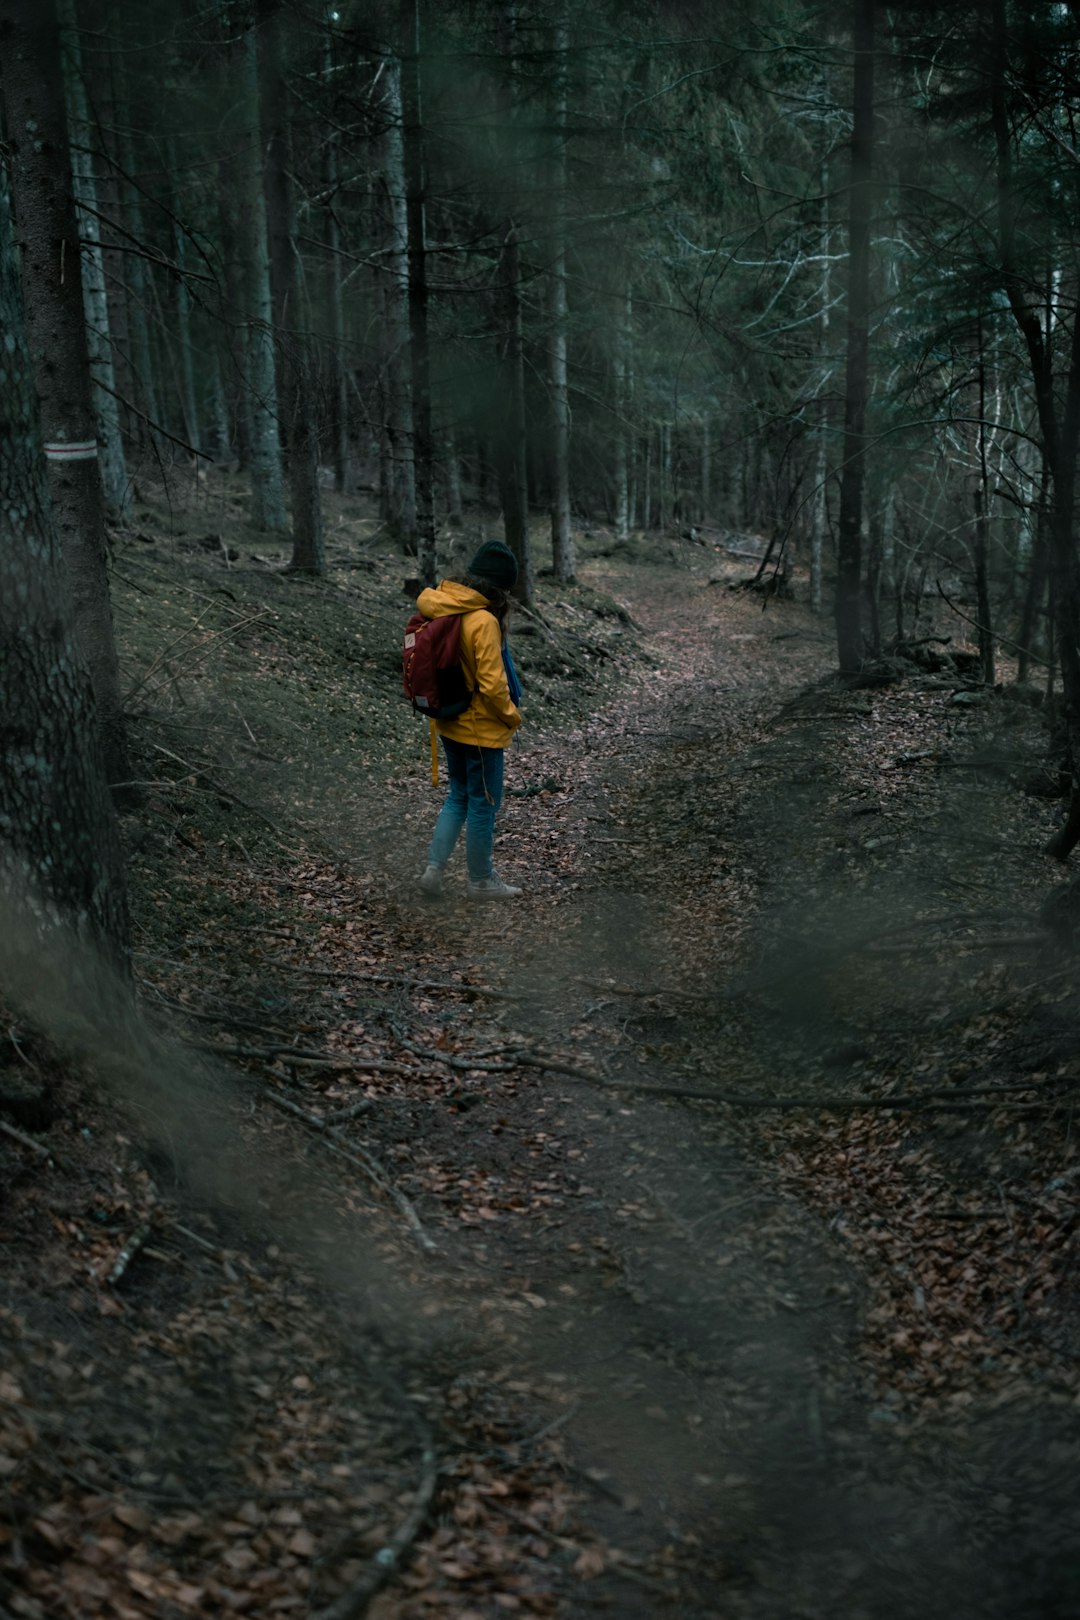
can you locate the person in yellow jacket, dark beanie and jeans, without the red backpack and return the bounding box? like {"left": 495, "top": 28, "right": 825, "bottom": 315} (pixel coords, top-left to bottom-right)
{"left": 416, "top": 539, "right": 521, "bottom": 901}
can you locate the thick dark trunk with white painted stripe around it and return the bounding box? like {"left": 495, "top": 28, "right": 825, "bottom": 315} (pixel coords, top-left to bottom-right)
{"left": 0, "top": 0, "right": 131, "bottom": 782}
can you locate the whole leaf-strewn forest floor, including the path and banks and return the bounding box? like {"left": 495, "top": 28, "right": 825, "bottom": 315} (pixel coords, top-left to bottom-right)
{"left": 0, "top": 479, "right": 1080, "bottom": 1620}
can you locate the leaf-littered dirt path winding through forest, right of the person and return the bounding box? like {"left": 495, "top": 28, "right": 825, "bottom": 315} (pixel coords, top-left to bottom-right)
{"left": 369, "top": 557, "right": 1075, "bottom": 1620}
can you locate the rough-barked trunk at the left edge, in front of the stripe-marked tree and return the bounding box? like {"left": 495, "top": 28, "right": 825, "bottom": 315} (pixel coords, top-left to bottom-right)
{"left": 0, "top": 169, "right": 128, "bottom": 959}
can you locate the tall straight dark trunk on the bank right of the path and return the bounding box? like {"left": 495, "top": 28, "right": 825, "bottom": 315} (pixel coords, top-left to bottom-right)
{"left": 836, "top": 0, "right": 876, "bottom": 674}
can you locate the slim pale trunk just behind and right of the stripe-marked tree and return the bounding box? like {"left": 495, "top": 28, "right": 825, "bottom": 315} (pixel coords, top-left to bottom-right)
{"left": 55, "top": 0, "right": 131, "bottom": 518}
